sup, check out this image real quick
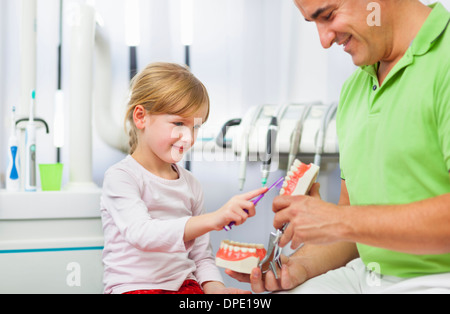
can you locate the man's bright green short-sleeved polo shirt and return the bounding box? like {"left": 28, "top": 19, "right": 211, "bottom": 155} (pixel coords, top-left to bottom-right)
{"left": 337, "top": 3, "right": 450, "bottom": 277}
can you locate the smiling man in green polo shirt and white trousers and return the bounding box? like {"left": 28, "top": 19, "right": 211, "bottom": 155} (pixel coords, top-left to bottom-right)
{"left": 227, "top": 0, "right": 450, "bottom": 293}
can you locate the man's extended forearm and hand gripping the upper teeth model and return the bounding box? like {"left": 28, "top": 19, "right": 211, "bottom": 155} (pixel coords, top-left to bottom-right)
{"left": 274, "top": 182, "right": 450, "bottom": 254}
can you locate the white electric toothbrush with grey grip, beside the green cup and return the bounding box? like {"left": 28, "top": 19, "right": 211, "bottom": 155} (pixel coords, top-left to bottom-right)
{"left": 25, "top": 90, "right": 37, "bottom": 192}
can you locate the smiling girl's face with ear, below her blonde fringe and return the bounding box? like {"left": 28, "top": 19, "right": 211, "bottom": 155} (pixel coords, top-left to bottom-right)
{"left": 135, "top": 106, "right": 207, "bottom": 164}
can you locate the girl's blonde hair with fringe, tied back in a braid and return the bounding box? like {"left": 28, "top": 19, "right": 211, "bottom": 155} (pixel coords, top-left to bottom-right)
{"left": 125, "top": 62, "right": 210, "bottom": 154}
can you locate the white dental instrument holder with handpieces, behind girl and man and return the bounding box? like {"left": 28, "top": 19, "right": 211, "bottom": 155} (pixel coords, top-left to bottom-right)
{"left": 223, "top": 102, "right": 339, "bottom": 166}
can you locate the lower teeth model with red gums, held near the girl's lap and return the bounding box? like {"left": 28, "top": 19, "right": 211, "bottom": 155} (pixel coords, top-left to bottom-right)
{"left": 216, "top": 240, "right": 266, "bottom": 274}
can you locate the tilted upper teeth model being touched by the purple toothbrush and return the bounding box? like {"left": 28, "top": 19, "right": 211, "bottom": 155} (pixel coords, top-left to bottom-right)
{"left": 280, "top": 159, "right": 320, "bottom": 195}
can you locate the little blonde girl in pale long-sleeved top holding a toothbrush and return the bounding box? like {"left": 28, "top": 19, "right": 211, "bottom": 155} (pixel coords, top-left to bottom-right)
{"left": 101, "top": 63, "right": 266, "bottom": 294}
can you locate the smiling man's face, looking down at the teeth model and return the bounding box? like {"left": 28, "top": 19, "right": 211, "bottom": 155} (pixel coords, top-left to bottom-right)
{"left": 294, "top": 0, "right": 389, "bottom": 66}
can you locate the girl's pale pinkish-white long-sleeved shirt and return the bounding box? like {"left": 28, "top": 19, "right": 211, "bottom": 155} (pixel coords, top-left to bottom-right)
{"left": 101, "top": 156, "right": 223, "bottom": 293}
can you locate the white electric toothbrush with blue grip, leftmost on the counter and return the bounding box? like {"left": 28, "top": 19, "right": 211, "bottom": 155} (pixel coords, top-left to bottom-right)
{"left": 6, "top": 106, "right": 20, "bottom": 192}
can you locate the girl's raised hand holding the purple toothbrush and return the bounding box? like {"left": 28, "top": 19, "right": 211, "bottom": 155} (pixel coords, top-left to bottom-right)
{"left": 211, "top": 188, "right": 267, "bottom": 231}
